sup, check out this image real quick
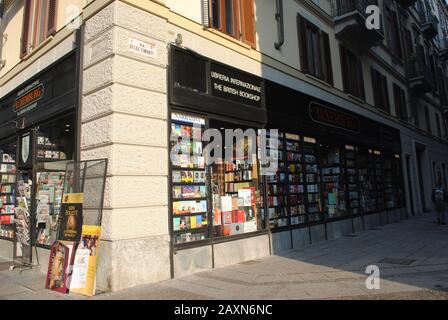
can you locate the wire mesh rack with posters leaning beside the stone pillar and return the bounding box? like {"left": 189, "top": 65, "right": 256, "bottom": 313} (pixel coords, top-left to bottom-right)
{"left": 44, "top": 160, "right": 107, "bottom": 296}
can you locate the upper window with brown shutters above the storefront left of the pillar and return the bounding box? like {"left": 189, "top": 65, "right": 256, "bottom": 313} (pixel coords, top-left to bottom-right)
{"left": 21, "top": 0, "right": 57, "bottom": 57}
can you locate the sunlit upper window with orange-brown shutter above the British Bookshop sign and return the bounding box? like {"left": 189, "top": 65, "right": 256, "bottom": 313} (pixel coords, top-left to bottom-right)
{"left": 209, "top": 0, "right": 256, "bottom": 49}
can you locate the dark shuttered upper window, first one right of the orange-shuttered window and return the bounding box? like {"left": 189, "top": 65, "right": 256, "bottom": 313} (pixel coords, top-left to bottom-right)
{"left": 297, "top": 14, "right": 333, "bottom": 84}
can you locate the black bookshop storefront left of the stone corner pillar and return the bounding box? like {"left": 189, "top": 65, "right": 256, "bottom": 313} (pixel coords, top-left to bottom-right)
{"left": 0, "top": 53, "right": 77, "bottom": 252}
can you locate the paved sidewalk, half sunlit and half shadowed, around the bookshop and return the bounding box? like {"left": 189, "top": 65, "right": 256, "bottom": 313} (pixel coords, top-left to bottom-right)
{"left": 0, "top": 214, "right": 448, "bottom": 300}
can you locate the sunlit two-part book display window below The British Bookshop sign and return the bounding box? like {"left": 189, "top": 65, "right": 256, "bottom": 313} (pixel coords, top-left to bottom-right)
{"left": 171, "top": 113, "right": 264, "bottom": 244}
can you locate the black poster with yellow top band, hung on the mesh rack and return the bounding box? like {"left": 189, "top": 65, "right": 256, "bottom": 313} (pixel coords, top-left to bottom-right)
{"left": 59, "top": 193, "right": 84, "bottom": 242}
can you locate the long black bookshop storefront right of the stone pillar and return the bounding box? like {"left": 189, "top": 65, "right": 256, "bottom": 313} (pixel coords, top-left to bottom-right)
{"left": 169, "top": 46, "right": 404, "bottom": 276}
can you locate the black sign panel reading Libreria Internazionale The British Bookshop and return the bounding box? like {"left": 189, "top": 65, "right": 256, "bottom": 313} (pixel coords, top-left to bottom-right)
{"left": 210, "top": 63, "right": 263, "bottom": 108}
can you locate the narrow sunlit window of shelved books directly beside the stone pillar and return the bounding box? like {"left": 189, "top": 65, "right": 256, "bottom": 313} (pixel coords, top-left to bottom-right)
{"left": 170, "top": 113, "right": 209, "bottom": 244}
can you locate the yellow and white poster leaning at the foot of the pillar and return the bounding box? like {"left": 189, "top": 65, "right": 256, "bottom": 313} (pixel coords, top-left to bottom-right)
{"left": 70, "top": 225, "right": 101, "bottom": 297}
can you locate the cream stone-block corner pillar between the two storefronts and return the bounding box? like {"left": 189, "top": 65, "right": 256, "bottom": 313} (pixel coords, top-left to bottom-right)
{"left": 81, "top": 1, "right": 170, "bottom": 291}
